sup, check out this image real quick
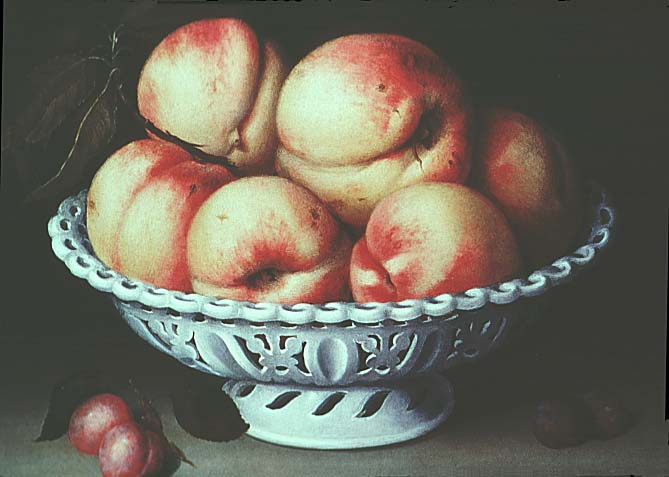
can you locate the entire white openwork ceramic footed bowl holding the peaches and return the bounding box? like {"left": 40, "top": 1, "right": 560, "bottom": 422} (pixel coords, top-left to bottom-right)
{"left": 48, "top": 186, "right": 615, "bottom": 449}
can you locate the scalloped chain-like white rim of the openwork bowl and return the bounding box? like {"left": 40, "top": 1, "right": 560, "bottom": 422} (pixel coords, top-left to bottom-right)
{"left": 48, "top": 182, "right": 616, "bottom": 325}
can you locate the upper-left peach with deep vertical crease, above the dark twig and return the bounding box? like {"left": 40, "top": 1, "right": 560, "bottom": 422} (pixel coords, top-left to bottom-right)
{"left": 137, "top": 18, "right": 287, "bottom": 174}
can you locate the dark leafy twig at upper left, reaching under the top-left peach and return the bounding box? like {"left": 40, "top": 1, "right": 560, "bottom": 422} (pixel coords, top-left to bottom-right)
{"left": 2, "top": 13, "right": 237, "bottom": 201}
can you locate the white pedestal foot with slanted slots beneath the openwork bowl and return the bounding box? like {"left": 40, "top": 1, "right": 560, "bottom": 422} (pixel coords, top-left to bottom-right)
{"left": 223, "top": 373, "right": 454, "bottom": 449}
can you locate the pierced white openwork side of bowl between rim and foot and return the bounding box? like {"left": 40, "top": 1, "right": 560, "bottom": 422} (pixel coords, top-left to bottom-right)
{"left": 115, "top": 300, "right": 522, "bottom": 386}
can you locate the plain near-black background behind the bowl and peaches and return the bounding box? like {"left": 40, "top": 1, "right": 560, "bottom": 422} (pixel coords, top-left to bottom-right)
{"left": 0, "top": 0, "right": 669, "bottom": 464}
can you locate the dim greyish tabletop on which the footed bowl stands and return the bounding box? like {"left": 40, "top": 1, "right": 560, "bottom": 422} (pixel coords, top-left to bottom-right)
{"left": 0, "top": 316, "right": 669, "bottom": 477}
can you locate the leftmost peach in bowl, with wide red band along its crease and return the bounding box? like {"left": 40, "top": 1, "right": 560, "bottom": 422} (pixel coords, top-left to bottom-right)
{"left": 86, "top": 139, "right": 235, "bottom": 292}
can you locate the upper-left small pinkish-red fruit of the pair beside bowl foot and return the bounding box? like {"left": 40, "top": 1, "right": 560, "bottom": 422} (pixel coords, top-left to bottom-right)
{"left": 68, "top": 393, "right": 132, "bottom": 455}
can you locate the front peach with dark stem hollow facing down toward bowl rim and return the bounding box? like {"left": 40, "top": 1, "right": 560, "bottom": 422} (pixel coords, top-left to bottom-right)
{"left": 188, "top": 176, "right": 352, "bottom": 303}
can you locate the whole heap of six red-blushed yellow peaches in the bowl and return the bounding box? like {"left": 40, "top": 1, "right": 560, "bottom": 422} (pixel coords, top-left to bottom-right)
{"left": 87, "top": 18, "right": 583, "bottom": 303}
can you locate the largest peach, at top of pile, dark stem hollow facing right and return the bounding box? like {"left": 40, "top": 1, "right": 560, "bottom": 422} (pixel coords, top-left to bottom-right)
{"left": 276, "top": 34, "right": 471, "bottom": 226}
